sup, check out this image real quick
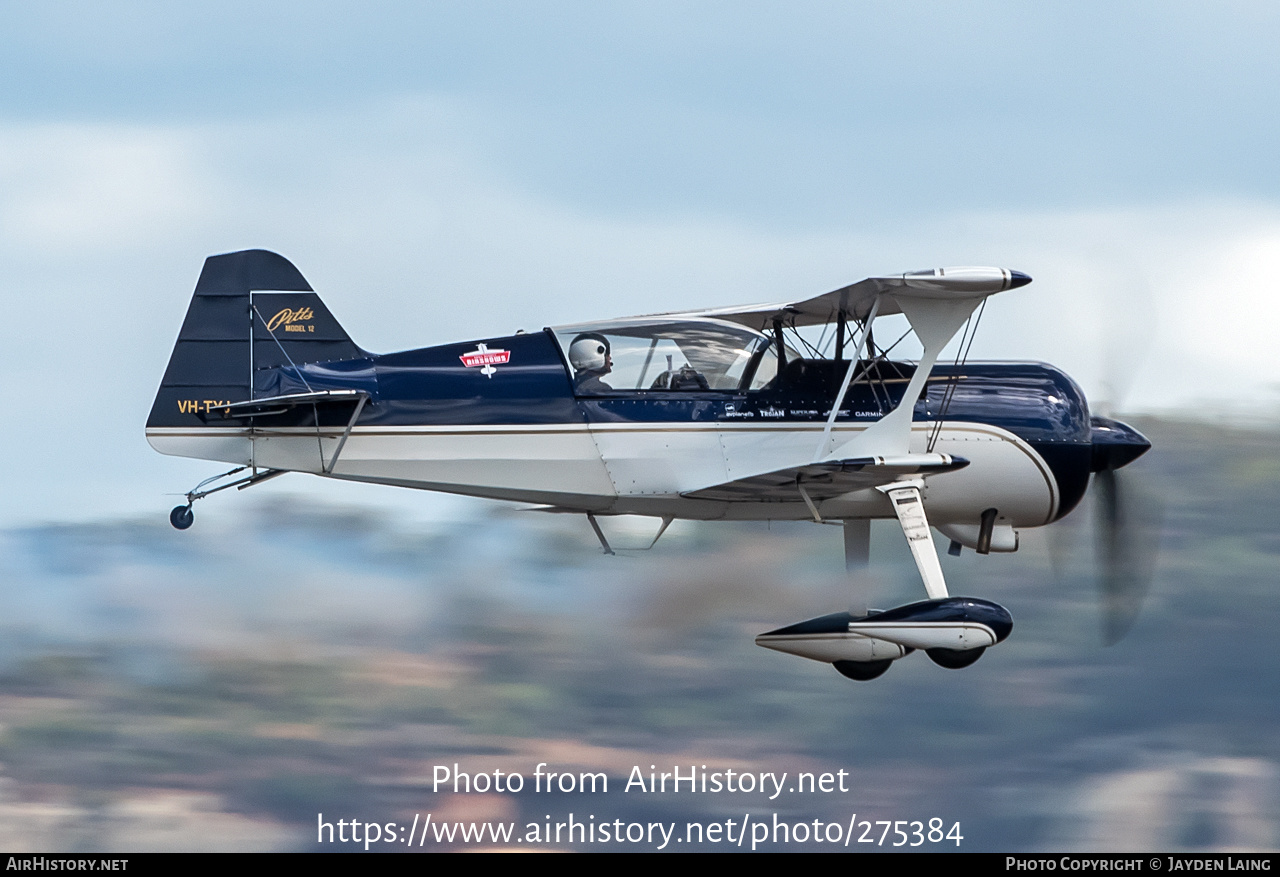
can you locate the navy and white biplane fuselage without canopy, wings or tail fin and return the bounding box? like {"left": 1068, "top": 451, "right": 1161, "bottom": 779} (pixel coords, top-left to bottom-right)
{"left": 147, "top": 322, "right": 1092, "bottom": 527}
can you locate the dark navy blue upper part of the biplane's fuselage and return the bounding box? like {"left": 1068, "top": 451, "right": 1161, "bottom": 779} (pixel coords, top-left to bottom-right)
{"left": 247, "top": 332, "right": 1093, "bottom": 516}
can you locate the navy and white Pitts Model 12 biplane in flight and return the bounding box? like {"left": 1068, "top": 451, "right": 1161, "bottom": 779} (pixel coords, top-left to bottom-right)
{"left": 146, "top": 250, "right": 1151, "bottom": 680}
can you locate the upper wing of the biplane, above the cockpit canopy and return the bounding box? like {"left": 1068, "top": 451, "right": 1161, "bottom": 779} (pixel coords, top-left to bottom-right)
{"left": 637, "top": 268, "right": 1032, "bottom": 329}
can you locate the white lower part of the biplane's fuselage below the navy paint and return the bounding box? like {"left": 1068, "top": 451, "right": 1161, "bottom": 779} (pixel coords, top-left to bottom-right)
{"left": 147, "top": 421, "right": 1060, "bottom": 527}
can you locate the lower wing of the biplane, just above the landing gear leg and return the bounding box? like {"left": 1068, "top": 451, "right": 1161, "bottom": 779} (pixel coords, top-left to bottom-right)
{"left": 680, "top": 453, "right": 969, "bottom": 502}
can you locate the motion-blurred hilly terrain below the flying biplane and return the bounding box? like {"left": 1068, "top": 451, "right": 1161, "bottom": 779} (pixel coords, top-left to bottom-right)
{"left": 0, "top": 419, "right": 1280, "bottom": 851}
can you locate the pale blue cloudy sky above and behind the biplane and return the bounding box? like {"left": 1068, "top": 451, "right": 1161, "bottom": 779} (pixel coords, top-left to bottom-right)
{"left": 0, "top": 1, "right": 1280, "bottom": 526}
